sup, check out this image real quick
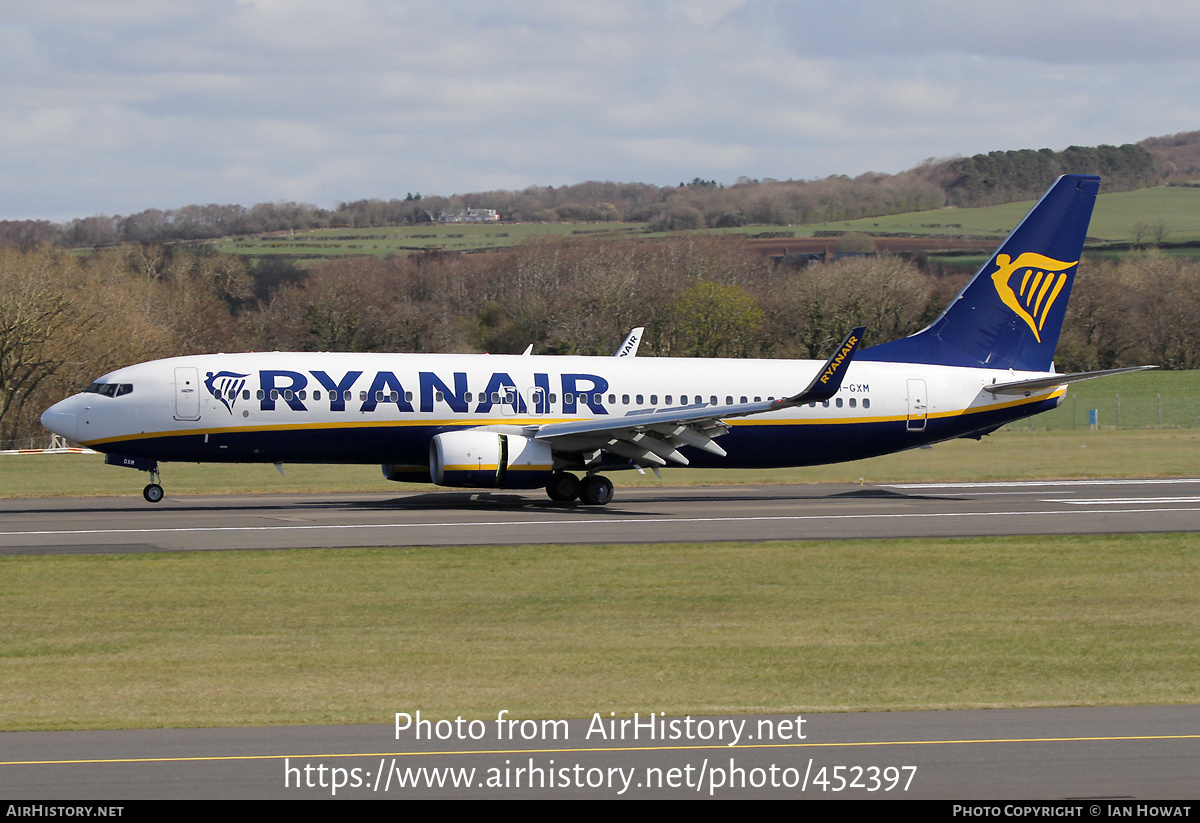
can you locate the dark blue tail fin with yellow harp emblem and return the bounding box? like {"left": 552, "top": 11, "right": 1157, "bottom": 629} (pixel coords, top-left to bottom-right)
{"left": 858, "top": 174, "right": 1100, "bottom": 372}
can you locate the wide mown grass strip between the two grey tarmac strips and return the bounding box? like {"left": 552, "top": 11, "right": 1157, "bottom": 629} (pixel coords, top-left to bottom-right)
{"left": 0, "top": 535, "right": 1200, "bottom": 729}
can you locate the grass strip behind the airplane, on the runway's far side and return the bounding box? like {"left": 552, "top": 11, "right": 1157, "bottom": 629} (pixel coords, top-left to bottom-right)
{"left": 7, "top": 429, "right": 1200, "bottom": 498}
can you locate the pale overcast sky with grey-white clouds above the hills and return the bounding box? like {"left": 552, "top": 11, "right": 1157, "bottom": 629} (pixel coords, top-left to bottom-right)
{"left": 0, "top": 0, "right": 1200, "bottom": 221}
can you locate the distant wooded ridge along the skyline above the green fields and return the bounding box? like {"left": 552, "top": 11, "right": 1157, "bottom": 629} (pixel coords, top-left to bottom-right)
{"left": 0, "top": 132, "right": 1200, "bottom": 248}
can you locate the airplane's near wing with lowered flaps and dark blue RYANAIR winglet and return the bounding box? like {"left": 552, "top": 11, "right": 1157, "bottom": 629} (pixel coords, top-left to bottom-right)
{"left": 533, "top": 326, "right": 865, "bottom": 468}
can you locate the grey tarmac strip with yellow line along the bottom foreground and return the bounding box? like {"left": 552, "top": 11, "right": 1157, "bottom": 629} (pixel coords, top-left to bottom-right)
{"left": 0, "top": 707, "right": 1200, "bottom": 801}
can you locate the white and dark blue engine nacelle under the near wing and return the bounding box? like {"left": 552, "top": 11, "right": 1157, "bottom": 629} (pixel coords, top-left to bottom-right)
{"left": 430, "top": 429, "right": 554, "bottom": 488}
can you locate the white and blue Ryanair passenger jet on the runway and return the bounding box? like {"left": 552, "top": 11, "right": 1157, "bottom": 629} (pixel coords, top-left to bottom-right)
{"left": 42, "top": 175, "right": 1142, "bottom": 505}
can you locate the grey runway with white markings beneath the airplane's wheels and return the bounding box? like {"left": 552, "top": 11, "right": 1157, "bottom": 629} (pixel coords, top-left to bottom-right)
{"left": 0, "top": 477, "right": 1200, "bottom": 554}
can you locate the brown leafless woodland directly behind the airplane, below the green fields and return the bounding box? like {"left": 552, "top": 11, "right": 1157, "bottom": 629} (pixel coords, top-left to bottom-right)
{"left": 0, "top": 235, "right": 1200, "bottom": 441}
